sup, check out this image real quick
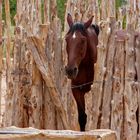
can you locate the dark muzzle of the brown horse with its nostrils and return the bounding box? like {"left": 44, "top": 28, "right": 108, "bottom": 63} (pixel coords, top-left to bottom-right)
{"left": 65, "top": 66, "right": 78, "bottom": 79}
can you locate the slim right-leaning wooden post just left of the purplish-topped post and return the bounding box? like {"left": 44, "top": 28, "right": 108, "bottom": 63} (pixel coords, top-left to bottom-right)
{"left": 100, "top": 18, "right": 116, "bottom": 128}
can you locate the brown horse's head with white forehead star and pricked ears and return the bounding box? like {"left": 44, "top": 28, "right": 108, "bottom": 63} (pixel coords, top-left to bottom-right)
{"left": 65, "top": 14, "right": 93, "bottom": 79}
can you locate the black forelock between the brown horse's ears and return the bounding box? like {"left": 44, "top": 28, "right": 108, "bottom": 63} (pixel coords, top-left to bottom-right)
{"left": 68, "top": 22, "right": 86, "bottom": 36}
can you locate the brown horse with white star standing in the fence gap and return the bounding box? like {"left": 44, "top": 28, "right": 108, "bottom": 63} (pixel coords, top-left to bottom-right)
{"left": 65, "top": 13, "right": 99, "bottom": 131}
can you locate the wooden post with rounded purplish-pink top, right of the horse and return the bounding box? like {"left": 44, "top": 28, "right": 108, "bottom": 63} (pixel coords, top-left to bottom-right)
{"left": 110, "top": 30, "right": 126, "bottom": 140}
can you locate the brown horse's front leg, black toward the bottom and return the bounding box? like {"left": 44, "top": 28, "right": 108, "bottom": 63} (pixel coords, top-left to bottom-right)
{"left": 72, "top": 88, "right": 87, "bottom": 131}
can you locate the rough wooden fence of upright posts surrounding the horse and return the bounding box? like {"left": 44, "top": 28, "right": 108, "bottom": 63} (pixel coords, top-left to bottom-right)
{"left": 0, "top": 0, "right": 140, "bottom": 140}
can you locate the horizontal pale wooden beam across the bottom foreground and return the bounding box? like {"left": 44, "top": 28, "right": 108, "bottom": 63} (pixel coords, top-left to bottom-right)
{"left": 0, "top": 127, "right": 117, "bottom": 140}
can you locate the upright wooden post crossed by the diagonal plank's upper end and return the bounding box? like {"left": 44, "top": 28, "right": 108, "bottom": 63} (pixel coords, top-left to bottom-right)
{"left": 29, "top": 0, "right": 44, "bottom": 129}
